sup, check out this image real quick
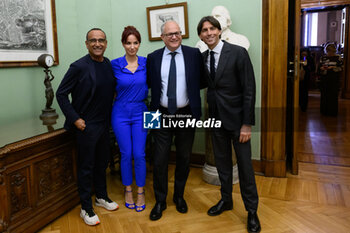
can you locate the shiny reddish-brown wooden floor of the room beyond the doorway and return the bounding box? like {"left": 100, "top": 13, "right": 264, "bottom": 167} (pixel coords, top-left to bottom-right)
{"left": 298, "top": 92, "right": 350, "bottom": 166}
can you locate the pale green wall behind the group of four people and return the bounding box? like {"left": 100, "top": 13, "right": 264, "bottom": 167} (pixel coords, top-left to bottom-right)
{"left": 0, "top": 0, "right": 262, "bottom": 159}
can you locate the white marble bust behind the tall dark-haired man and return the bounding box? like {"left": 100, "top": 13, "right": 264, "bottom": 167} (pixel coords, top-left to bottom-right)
{"left": 196, "top": 6, "right": 250, "bottom": 52}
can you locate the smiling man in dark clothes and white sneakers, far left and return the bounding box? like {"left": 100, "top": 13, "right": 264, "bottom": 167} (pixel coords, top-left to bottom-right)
{"left": 56, "top": 28, "right": 118, "bottom": 225}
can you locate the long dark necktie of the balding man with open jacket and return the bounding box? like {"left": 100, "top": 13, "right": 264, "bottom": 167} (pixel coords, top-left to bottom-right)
{"left": 167, "top": 52, "right": 177, "bottom": 114}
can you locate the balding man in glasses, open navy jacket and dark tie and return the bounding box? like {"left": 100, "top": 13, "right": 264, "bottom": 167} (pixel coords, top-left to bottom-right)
{"left": 147, "top": 21, "right": 203, "bottom": 220}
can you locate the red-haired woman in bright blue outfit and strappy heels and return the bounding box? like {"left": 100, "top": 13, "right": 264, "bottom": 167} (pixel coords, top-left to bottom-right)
{"left": 111, "top": 26, "right": 148, "bottom": 212}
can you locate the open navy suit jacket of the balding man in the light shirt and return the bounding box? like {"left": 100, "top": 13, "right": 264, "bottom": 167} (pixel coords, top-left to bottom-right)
{"left": 147, "top": 45, "right": 204, "bottom": 119}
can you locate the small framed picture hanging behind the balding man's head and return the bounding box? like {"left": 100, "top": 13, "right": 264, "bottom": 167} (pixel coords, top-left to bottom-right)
{"left": 147, "top": 2, "right": 188, "bottom": 41}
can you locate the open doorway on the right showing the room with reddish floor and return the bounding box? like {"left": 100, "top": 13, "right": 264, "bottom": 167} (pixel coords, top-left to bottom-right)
{"left": 297, "top": 5, "right": 350, "bottom": 166}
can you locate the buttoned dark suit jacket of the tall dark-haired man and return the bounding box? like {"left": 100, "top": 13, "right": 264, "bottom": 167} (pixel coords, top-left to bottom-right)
{"left": 202, "top": 41, "right": 255, "bottom": 131}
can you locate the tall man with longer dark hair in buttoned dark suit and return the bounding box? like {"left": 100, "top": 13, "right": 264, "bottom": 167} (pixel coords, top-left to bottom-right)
{"left": 197, "top": 16, "right": 261, "bottom": 232}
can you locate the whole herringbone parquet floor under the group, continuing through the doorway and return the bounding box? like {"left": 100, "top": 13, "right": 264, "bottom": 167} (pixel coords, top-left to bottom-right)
{"left": 40, "top": 92, "right": 350, "bottom": 233}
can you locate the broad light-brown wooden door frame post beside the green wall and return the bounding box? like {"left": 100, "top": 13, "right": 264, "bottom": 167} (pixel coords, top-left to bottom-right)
{"left": 260, "top": 0, "right": 288, "bottom": 177}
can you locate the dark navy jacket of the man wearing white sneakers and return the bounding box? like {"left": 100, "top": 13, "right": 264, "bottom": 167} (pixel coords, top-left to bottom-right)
{"left": 56, "top": 54, "right": 115, "bottom": 130}
